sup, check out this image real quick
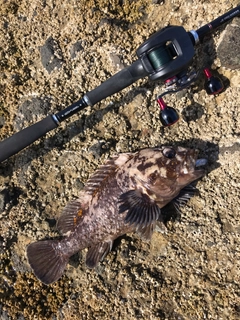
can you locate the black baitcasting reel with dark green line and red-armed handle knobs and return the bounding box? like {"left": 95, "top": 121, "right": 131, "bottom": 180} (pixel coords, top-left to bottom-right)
{"left": 137, "top": 24, "right": 223, "bottom": 126}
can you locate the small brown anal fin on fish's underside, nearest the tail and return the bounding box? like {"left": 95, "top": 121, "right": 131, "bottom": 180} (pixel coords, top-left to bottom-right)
{"left": 86, "top": 241, "right": 112, "bottom": 269}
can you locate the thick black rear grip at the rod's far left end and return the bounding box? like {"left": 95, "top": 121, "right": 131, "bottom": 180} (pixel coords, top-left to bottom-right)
{"left": 0, "top": 115, "right": 57, "bottom": 162}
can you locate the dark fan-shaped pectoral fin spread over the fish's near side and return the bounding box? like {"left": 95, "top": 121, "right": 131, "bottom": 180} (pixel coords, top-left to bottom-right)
{"left": 119, "top": 190, "right": 161, "bottom": 228}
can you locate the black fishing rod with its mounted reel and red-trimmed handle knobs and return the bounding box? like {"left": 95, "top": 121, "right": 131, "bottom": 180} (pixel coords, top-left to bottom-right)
{"left": 0, "top": 6, "right": 240, "bottom": 162}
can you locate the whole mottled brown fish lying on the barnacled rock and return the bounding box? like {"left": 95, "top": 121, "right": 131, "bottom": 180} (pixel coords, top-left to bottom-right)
{"left": 27, "top": 146, "right": 207, "bottom": 285}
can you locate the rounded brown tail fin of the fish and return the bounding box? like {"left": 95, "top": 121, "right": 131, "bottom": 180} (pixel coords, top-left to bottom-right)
{"left": 27, "top": 240, "right": 68, "bottom": 284}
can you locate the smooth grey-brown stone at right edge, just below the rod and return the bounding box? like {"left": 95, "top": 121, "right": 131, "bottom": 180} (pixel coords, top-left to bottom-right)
{"left": 217, "top": 18, "right": 240, "bottom": 70}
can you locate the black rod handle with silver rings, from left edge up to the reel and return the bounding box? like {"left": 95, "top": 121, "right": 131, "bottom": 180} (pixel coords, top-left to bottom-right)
{"left": 0, "top": 60, "right": 147, "bottom": 162}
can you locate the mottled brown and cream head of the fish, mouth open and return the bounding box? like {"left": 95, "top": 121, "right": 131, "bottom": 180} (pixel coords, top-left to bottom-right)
{"left": 130, "top": 146, "right": 207, "bottom": 207}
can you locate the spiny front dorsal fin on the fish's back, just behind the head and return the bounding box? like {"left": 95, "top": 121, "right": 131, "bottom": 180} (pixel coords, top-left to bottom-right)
{"left": 84, "top": 153, "right": 132, "bottom": 195}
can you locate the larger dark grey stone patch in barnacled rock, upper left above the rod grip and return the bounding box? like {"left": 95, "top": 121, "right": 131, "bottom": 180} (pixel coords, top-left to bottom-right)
{"left": 40, "top": 37, "right": 63, "bottom": 73}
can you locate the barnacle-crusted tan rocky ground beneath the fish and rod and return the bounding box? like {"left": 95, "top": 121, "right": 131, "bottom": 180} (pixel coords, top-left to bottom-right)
{"left": 0, "top": 0, "right": 240, "bottom": 320}
